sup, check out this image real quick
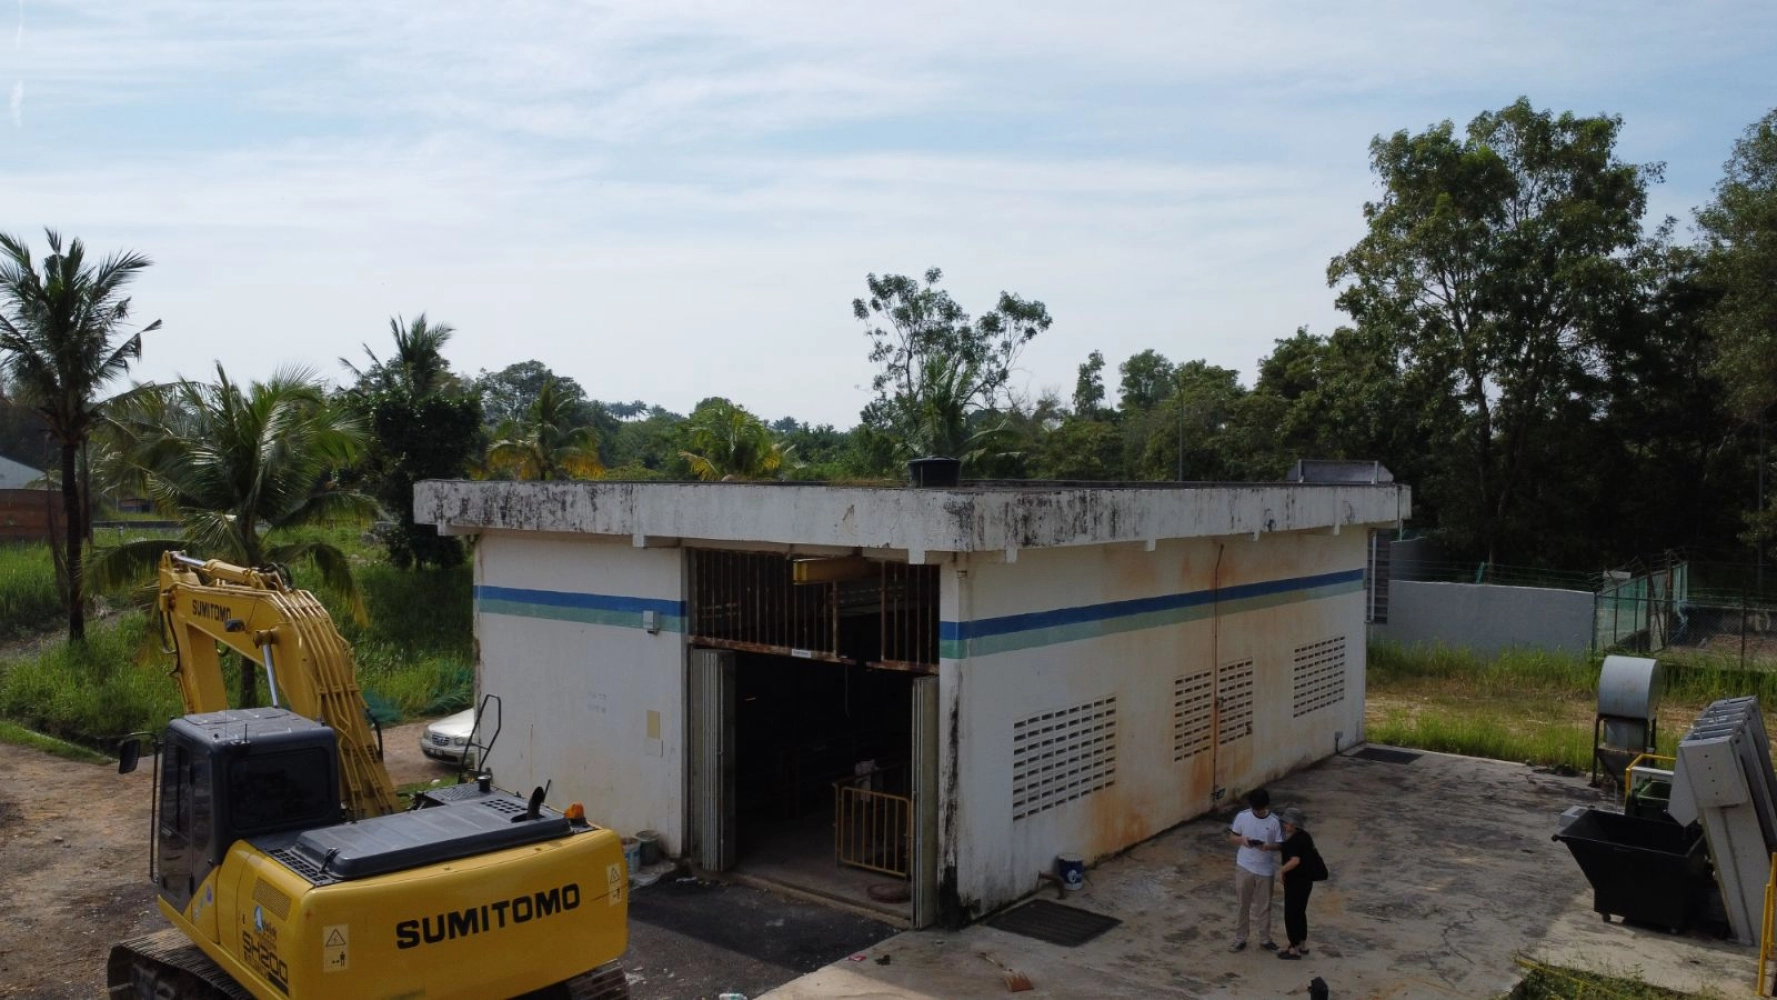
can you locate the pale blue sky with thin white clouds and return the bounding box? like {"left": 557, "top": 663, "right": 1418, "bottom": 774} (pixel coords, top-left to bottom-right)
{"left": 0, "top": 0, "right": 1777, "bottom": 428}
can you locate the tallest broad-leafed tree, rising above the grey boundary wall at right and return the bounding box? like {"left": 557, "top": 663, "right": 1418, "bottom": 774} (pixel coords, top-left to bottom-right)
{"left": 1327, "top": 99, "right": 1661, "bottom": 561}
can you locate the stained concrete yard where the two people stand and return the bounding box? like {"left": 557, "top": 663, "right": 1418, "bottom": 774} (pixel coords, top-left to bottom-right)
{"left": 764, "top": 753, "right": 1757, "bottom": 1000}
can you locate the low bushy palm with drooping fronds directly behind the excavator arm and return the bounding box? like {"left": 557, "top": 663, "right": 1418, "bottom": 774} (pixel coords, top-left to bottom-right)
{"left": 92, "top": 366, "right": 375, "bottom": 705}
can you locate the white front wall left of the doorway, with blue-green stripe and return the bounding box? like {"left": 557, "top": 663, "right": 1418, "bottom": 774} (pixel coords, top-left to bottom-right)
{"left": 474, "top": 531, "right": 684, "bottom": 851}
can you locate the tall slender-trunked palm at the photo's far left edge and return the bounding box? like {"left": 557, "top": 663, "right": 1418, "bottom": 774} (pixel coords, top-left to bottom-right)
{"left": 0, "top": 229, "right": 160, "bottom": 641}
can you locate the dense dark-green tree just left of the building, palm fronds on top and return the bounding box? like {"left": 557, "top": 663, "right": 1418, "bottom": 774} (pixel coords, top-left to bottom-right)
{"left": 339, "top": 313, "right": 482, "bottom": 568}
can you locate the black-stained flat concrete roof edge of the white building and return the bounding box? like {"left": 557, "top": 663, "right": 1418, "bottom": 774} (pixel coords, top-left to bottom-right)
{"left": 414, "top": 480, "right": 1413, "bottom": 554}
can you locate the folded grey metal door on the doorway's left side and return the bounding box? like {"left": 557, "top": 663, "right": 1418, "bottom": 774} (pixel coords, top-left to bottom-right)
{"left": 688, "top": 650, "right": 734, "bottom": 872}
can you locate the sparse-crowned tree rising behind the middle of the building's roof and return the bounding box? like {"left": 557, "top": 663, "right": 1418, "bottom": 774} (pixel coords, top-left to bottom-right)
{"left": 851, "top": 268, "right": 1052, "bottom": 460}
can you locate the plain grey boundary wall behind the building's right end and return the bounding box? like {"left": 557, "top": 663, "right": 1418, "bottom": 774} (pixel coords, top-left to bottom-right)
{"left": 1370, "top": 579, "right": 1594, "bottom": 655}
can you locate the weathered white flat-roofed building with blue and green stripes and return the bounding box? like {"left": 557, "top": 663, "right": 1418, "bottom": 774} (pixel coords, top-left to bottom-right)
{"left": 414, "top": 481, "right": 1411, "bottom": 925}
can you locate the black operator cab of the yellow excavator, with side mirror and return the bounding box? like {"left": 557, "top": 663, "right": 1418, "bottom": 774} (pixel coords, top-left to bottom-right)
{"left": 124, "top": 709, "right": 343, "bottom": 911}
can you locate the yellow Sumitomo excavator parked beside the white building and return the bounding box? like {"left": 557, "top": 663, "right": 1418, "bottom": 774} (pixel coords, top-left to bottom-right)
{"left": 107, "top": 552, "right": 629, "bottom": 1000}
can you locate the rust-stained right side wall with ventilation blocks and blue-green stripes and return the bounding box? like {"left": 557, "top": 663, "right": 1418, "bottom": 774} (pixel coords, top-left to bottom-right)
{"left": 942, "top": 531, "right": 1365, "bottom": 911}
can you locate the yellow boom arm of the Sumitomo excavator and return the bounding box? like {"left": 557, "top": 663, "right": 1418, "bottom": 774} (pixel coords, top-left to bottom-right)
{"left": 160, "top": 552, "right": 400, "bottom": 819}
